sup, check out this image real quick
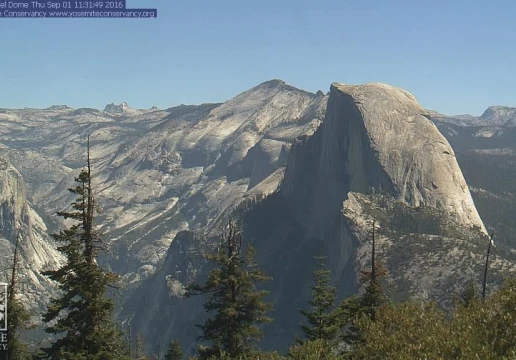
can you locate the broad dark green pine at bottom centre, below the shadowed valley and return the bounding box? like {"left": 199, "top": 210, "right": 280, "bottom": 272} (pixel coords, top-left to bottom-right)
{"left": 187, "top": 222, "right": 271, "bottom": 359}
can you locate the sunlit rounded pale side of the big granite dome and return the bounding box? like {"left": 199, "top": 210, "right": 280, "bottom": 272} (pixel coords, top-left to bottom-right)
{"left": 328, "top": 84, "right": 483, "bottom": 229}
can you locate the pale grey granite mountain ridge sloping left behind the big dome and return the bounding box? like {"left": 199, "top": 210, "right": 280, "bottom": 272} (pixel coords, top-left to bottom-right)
{"left": 0, "top": 80, "right": 326, "bottom": 283}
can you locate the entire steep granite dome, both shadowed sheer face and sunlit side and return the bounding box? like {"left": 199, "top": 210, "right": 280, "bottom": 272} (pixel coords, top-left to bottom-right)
{"left": 284, "top": 83, "right": 484, "bottom": 229}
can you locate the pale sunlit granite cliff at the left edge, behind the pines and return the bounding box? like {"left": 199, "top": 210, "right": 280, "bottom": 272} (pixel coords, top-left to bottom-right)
{"left": 0, "top": 158, "right": 62, "bottom": 307}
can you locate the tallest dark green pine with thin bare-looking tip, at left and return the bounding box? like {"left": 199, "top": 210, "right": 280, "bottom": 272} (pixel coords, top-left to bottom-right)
{"left": 40, "top": 138, "right": 128, "bottom": 360}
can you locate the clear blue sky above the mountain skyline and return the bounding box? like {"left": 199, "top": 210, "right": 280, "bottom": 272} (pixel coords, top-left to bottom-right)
{"left": 0, "top": 0, "right": 516, "bottom": 115}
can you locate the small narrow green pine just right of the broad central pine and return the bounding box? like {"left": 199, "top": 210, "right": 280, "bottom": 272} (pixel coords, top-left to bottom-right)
{"left": 301, "top": 257, "right": 340, "bottom": 341}
